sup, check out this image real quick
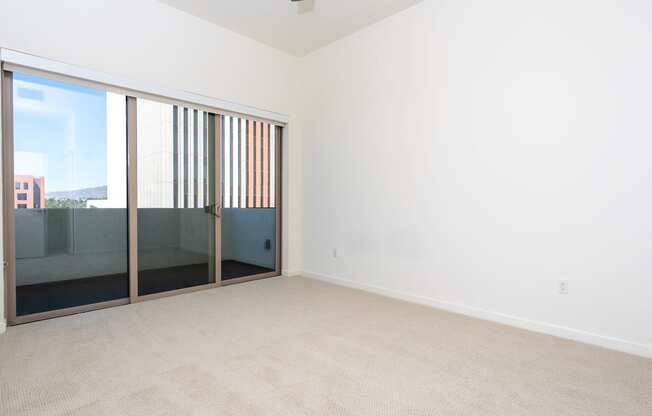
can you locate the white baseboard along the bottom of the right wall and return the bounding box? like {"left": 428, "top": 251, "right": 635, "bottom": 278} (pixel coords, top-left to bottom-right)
{"left": 301, "top": 271, "right": 652, "bottom": 358}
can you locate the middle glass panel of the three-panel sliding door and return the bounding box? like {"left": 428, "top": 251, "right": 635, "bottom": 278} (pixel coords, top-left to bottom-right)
{"left": 137, "top": 98, "right": 219, "bottom": 296}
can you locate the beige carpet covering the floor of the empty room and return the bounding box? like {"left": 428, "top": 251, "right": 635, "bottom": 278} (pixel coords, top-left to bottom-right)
{"left": 0, "top": 278, "right": 652, "bottom": 416}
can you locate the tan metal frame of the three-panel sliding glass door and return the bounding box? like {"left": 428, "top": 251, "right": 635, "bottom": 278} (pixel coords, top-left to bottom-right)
{"left": 0, "top": 67, "right": 283, "bottom": 325}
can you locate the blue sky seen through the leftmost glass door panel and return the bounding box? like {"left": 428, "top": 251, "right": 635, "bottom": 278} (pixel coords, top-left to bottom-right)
{"left": 14, "top": 73, "right": 107, "bottom": 192}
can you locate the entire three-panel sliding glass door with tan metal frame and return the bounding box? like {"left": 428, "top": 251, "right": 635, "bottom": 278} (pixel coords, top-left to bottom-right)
{"left": 2, "top": 70, "right": 282, "bottom": 324}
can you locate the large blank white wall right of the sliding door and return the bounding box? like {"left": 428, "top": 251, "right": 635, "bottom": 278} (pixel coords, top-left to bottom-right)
{"left": 301, "top": 0, "right": 652, "bottom": 355}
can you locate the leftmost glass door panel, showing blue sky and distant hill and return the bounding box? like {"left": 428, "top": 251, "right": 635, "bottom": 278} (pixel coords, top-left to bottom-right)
{"left": 8, "top": 73, "right": 129, "bottom": 316}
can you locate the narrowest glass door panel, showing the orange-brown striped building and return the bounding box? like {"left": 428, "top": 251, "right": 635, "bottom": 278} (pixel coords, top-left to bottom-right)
{"left": 221, "top": 116, "right": 280, "bottom": 281}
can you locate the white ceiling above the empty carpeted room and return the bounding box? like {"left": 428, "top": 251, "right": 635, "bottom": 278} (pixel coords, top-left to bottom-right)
{"left": 159, "top": 0, "right": 422, "bottom": 56}
